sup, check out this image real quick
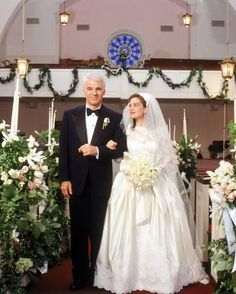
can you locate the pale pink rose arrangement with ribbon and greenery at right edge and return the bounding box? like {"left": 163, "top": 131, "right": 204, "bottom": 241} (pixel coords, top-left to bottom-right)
{"left": 206, "top": 122, "right": 236, "bottom": 294}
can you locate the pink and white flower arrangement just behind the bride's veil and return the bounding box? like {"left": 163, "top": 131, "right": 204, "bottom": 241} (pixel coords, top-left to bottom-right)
{"left": 173, "top": 135, "right": 201, "bottom": 182}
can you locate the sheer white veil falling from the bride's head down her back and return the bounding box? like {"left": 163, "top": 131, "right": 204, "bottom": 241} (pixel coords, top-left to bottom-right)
{"left": 123, "top": 93, "right": 196, "bottom": 244}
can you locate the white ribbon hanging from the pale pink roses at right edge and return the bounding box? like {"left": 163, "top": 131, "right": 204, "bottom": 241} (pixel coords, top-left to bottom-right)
{"left": 209, "top": 189, "right": 236, "bottom": 273}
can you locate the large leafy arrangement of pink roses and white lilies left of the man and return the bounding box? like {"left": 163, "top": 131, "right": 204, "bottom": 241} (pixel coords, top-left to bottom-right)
{"left": 0, "top": 121, "right": 69, "bottom": 293}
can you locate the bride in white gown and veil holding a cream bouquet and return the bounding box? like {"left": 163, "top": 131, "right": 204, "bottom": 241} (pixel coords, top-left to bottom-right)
{"left": 94, "top": 93, "right": 208, "bottom": 294}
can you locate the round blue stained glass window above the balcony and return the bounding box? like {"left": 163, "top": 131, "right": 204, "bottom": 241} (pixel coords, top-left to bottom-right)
{"left": 107, "top": 33, "right": 142, "bottom": 67}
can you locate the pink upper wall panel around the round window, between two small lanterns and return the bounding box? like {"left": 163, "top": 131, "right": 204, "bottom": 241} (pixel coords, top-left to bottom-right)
{"left": 61, "top": 0, "right": 188, "bottom": 59}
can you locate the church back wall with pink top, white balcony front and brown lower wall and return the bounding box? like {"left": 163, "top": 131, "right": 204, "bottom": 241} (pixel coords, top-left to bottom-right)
{"left": 0, "top": 0, "right": 236, "bottom": 158}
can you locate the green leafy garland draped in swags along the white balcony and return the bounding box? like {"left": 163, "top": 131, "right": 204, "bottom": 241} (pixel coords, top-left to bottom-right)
{"left": 0, "top": 64, "right": 232, "bottom": 100}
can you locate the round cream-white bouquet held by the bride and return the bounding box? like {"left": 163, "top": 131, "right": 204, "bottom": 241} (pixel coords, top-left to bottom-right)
{"left": 120, "top": 152, "right": 159, "bottom": 190}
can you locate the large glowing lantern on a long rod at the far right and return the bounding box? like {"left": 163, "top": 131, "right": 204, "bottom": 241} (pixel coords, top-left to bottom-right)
{"left": 220, "top": 0, "right": 235, "bottom": 80}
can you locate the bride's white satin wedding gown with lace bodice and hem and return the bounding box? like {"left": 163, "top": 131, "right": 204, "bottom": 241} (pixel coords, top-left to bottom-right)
{"left": 94, "top": 127, "right": 207, "bottom": 294}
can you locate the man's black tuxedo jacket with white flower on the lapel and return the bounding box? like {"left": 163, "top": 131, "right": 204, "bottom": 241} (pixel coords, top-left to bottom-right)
{"left": 59, "top": 105, "right": 127, "bottom": 197}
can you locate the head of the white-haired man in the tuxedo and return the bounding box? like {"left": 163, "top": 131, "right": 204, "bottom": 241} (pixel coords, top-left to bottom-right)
{"left": 84, "top": 80, "right": 105, "bottom": 109}
